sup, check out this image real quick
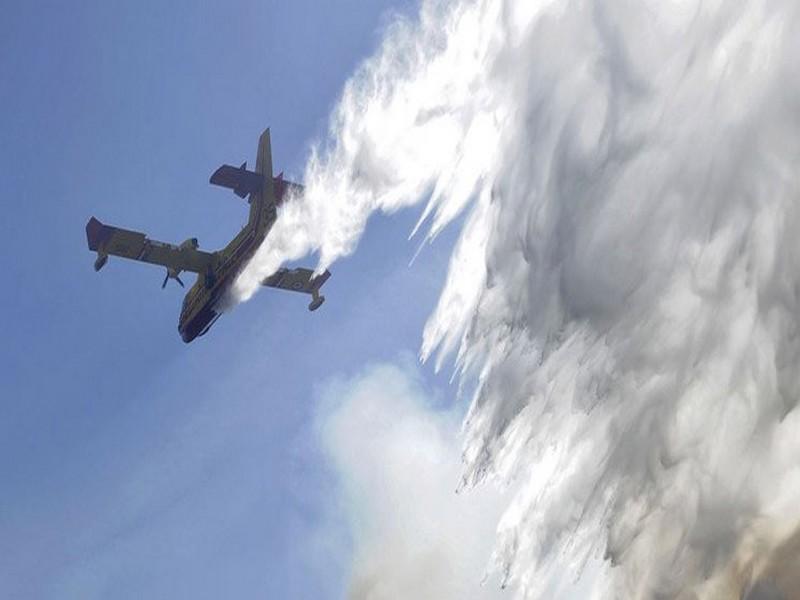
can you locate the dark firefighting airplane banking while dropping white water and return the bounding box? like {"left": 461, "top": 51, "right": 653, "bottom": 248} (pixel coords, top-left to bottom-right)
{"left": 86, "top": 128, "right": 331, "bottom": 344}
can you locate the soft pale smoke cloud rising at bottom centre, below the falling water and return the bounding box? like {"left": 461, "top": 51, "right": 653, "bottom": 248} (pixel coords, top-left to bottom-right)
{"left": 319, "top": 366, "right": 505, "bottom": 600}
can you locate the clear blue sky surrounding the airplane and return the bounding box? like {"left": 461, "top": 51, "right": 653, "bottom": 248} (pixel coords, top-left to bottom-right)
{"left": 0, "top": 0, "right": 466, "bottom": 598}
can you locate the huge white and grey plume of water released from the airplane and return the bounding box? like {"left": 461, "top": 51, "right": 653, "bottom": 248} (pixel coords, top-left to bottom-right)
{"left": 241, "top": 0, "right": 800, "bottom": 598}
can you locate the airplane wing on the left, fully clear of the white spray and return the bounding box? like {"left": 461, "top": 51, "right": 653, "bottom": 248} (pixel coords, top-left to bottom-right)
{"left": 86, "top": 217, "right": 214, "bottom": 273}
